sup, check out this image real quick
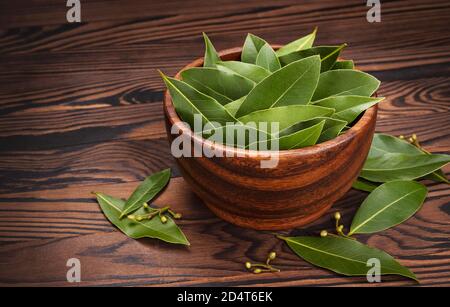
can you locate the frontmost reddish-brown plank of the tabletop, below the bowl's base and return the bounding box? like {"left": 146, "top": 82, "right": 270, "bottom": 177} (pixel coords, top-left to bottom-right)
{"left": 0, "top": 178, "right": 450, "bottom": 286}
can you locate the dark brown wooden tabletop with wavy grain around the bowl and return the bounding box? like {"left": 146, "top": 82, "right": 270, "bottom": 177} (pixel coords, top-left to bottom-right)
{"left": 0, "top": 0, "right": 450, "bottom": 286}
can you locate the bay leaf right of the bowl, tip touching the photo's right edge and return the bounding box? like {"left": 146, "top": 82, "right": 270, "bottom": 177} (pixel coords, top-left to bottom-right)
{"left": 359, "top": 153, "right": 450, "bottom": 182}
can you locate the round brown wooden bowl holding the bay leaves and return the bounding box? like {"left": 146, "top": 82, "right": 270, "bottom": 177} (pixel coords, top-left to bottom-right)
{"left": 164, "top": 46, "right": 377, "bottom": 230}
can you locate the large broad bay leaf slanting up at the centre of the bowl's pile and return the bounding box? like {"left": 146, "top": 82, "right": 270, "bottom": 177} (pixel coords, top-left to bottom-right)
{"left": 236, "top": 55, "right": 320, "bottom": 117}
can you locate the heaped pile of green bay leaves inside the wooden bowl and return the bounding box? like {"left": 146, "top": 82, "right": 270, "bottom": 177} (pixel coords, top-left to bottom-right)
{"left": 161, "top": 30, "right": 383, "bottom": 150}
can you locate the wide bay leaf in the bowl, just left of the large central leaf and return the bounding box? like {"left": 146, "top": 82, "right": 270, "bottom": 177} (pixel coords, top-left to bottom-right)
{"left": 181, "top": 67, "right": 255, "bottom": 105}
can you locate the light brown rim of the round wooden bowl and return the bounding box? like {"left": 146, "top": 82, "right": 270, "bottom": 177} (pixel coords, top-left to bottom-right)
{"left": 163, "top": 44, "right": 378, "bottom": 159}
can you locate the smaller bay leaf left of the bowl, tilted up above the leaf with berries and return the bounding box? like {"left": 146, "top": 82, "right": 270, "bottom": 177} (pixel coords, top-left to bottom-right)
{"left": 119, "top": 168, "right": 170, "bottom": 218}
